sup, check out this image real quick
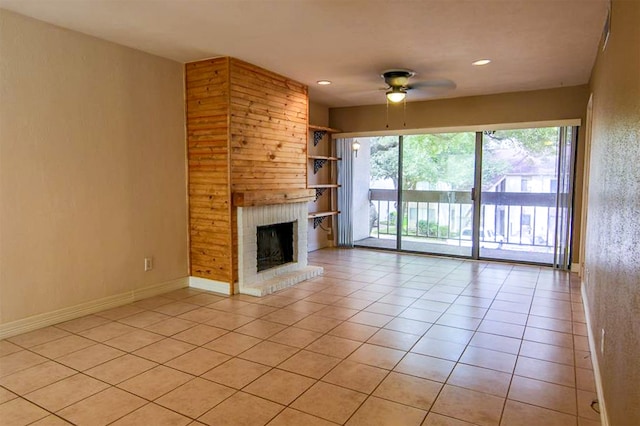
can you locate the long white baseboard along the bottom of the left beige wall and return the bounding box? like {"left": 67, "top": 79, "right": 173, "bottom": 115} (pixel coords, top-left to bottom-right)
{"left": 0, "top": 277, "right": 188, "bottom": 339}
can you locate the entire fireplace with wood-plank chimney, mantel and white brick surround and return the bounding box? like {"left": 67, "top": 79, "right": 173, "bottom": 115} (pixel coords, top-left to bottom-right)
{"left": 185, "top": 57, "right": 317, "bottom": 295}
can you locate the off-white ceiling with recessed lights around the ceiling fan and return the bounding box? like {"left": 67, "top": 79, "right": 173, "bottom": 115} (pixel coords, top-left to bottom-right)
{"left": 0, "top": 0, "right": 608, "bottom": 107}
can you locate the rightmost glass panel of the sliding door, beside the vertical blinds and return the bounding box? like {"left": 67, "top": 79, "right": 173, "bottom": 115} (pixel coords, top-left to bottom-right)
{"left": 479, "top": 127, "right": 561, "bottom": 264}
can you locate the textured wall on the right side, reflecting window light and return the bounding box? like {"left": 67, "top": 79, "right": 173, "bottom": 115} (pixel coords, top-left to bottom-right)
{"left": 584, "top": 0, "right": 640, "bottom": 425}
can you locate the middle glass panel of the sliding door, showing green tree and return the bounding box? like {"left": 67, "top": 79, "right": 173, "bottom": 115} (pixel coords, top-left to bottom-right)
{"left": 399, "top": 132, "right": 476, "bottom": 256}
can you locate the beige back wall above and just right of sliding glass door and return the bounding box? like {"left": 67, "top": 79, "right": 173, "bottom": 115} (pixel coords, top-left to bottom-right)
{"left": 329, "top": 85, "right": 589, "bottom": 264}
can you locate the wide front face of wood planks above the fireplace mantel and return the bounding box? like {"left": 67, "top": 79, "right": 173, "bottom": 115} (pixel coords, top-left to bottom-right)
{"left": 229, "top": 59, "right": 308, "bottom": 279}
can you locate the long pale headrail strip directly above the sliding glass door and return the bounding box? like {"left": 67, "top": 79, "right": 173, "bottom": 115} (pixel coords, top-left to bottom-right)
{"left": 331, "top": 118, "right": 582, "bottom": 139}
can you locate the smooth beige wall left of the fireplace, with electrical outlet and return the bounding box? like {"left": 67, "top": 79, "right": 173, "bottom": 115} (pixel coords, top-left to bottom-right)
{"left": 0, "top": 11, "right": 188, "bottom": 323}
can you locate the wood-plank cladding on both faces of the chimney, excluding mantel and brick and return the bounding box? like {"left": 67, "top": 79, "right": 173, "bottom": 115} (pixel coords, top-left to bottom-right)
{"left": 186, "top": 58, "right": 309, "bottom": 293}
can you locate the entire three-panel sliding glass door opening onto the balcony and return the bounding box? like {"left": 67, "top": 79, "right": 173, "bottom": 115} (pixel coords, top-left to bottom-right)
{"left": 353, "top": 127, "right": 576, "bottom": 268}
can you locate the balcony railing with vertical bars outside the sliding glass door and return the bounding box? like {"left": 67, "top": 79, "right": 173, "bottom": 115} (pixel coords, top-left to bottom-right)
{"left": 369, "top": 189, "right": 556, "bottom": 248}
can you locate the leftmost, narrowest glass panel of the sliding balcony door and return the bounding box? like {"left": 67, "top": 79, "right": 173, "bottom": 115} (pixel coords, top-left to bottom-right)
{"left": 353, "top": 136, "right": 400, "bottom": 249}
